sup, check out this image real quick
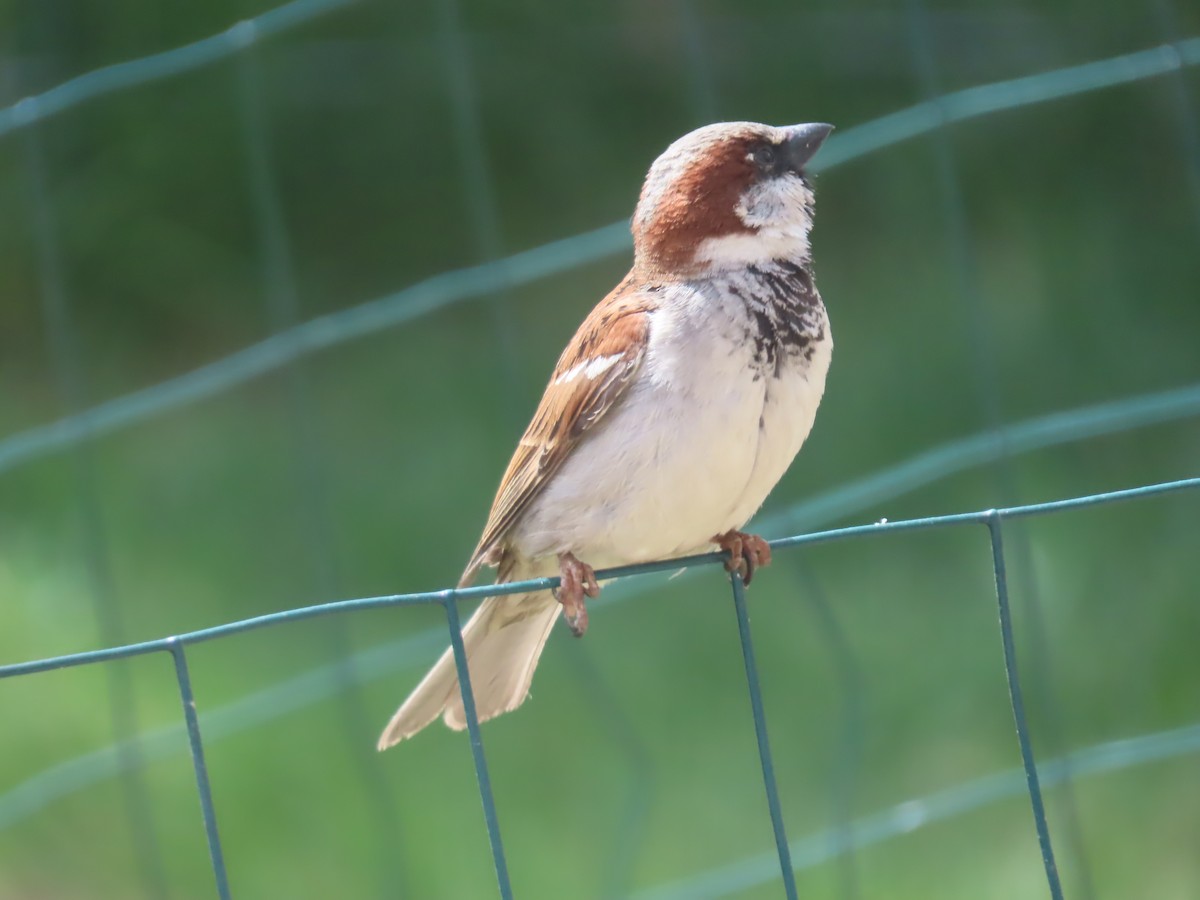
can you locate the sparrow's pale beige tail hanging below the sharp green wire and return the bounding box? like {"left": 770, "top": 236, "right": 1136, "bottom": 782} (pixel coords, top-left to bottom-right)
{"left": 378, "top": 590, "right": 559, "bottom": 750}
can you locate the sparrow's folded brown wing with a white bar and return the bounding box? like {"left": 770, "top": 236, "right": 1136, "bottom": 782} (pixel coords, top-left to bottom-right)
{"left": 458, "top": 278, "right": 650, "bottom": 587}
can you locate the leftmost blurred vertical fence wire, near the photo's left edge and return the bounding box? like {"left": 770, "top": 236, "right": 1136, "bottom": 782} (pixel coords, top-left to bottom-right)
{"left": 24, "top": 116, "right": 168, "bottom": 898}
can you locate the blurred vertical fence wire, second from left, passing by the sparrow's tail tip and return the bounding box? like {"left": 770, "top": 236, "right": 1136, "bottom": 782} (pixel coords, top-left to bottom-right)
{"left": 236, "top": 40, "right": 407, "bottom": 896}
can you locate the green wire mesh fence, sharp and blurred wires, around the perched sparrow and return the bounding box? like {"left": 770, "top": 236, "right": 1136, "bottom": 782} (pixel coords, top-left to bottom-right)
{"left": 0, "top": 0, "right": 1200, "bottom": 900}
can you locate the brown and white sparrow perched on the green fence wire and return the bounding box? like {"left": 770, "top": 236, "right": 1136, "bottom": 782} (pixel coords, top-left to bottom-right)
{"left": 378, "top": 121, "right": 833, "bottom": 750}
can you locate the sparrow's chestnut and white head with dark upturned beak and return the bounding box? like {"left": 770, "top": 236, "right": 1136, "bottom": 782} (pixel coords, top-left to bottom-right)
{"left": 634, "top": 122, "right": 833, "bottom": 277}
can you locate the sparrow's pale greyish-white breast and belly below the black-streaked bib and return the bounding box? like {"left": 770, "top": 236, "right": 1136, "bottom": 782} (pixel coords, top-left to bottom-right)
{"left": 512, "top": 266, "right": 832, "bottom": 566}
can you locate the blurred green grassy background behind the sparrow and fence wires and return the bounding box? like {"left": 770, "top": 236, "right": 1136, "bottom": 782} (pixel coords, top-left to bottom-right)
{"left": 0, "top": 0, "right": 1200, "bottom": 900}
